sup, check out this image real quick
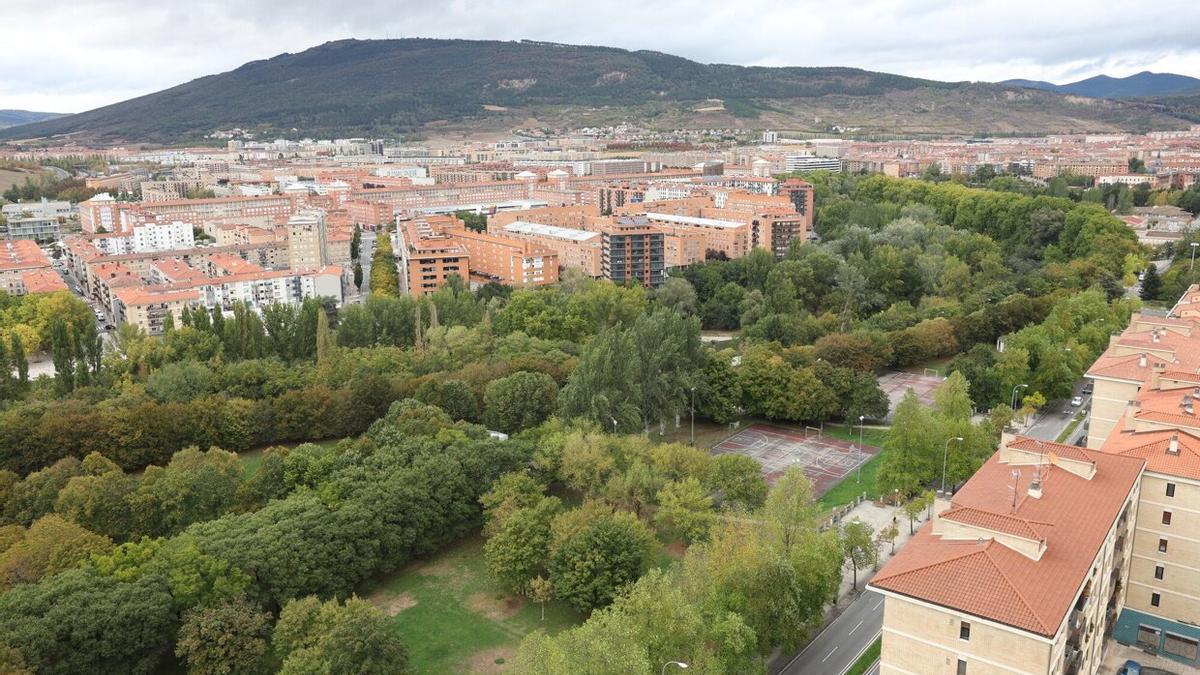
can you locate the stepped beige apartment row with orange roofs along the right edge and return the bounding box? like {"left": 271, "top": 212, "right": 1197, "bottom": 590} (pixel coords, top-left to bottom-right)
{"left": 1087, "top": 281, "right": 1200, "bottom": 668}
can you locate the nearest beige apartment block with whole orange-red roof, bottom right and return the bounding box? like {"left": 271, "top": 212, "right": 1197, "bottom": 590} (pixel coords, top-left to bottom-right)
{"left": 869, "top": 434, "right": 1145, "bottom": 675}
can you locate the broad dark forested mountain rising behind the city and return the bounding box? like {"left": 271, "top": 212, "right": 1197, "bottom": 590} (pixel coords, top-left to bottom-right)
{"left": 0, "top": 38, "right": 1186, "bottom": 143}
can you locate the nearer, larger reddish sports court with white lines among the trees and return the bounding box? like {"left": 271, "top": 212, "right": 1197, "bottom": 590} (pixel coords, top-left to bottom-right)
{"left": 713, "top": 424, "right": 878, "bottom": 496}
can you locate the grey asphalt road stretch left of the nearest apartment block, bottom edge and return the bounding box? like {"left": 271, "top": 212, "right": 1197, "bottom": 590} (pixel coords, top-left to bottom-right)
{"left": 780, "top": 591, "right": 883, "bottom": 675}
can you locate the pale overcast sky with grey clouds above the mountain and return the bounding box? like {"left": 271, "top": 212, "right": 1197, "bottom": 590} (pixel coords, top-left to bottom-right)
{"left": 0, "top": 0, "right": 1200, "bottom": 112}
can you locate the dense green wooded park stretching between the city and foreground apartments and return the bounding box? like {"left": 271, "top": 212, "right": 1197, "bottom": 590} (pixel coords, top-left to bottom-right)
{"left": 0, "top": 169, "right": 1156, "bottom": 673}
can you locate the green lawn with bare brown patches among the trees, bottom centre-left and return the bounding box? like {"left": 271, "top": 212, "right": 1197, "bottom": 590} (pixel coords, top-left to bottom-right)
{"left": 359, "top": 536, "right": 584, "bottom": 673}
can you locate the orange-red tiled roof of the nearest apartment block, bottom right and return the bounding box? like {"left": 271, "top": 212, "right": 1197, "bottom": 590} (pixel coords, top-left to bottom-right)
{"left": 871, "top": 437, "right": 1144, "bottom": 637}
